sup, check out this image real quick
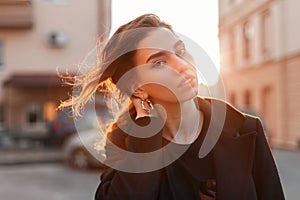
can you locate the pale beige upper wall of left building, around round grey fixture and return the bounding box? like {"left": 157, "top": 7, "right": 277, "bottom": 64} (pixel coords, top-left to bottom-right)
{"left": 0, "top": 0, "right": 99, "bottom": 101}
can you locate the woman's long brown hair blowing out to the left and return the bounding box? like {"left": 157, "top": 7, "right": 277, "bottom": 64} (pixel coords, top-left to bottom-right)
{"left": 58, "top": 14, "right": 173, "bottom": 130}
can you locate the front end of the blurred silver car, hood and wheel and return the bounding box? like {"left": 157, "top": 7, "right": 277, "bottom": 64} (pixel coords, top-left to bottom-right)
{"left": 63, "top": 129, "right": 105, "bottom": 169}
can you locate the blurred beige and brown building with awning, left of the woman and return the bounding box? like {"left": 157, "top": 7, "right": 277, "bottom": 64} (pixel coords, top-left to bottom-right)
{"left": 0, "top": 0, "right": 111, "bottom": 141}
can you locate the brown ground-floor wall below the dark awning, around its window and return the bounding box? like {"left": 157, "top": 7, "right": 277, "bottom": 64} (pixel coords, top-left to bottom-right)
{"left": 4, "top": 87, "right": 68, "bottom": 136}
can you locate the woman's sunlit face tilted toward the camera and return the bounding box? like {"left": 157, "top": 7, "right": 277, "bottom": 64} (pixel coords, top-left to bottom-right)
{"left": 134, "top": 28, "right": 198, "bottom": 103}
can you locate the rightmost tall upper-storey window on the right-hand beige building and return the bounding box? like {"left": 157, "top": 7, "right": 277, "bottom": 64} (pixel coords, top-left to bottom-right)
{"left": 261, "top": 10, "right": 272, "bottom": 59}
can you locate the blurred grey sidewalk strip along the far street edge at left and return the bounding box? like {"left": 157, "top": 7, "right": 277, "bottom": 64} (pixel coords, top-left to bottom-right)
{"left": 0, "top": 148, "right": 63, "bottom": 165}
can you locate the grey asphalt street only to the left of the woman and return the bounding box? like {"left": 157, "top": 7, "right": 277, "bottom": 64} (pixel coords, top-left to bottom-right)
{"left": 0, "top": 163, "right": 100, "bottom": 200}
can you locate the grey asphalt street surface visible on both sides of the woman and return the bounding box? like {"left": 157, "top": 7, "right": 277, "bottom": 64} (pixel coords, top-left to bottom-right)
{"left": 0, "top": 150, "right": 300, "bottom": 200}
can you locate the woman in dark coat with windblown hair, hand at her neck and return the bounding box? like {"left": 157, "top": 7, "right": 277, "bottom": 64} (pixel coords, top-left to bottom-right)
{"left": 60, "top": 14, "right": 284, "bottom": 200}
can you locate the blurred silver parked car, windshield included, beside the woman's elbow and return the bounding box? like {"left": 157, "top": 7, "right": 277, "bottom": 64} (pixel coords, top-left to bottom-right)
{"left": 63, "top": 110, "right": 112, "bottom": 168}
